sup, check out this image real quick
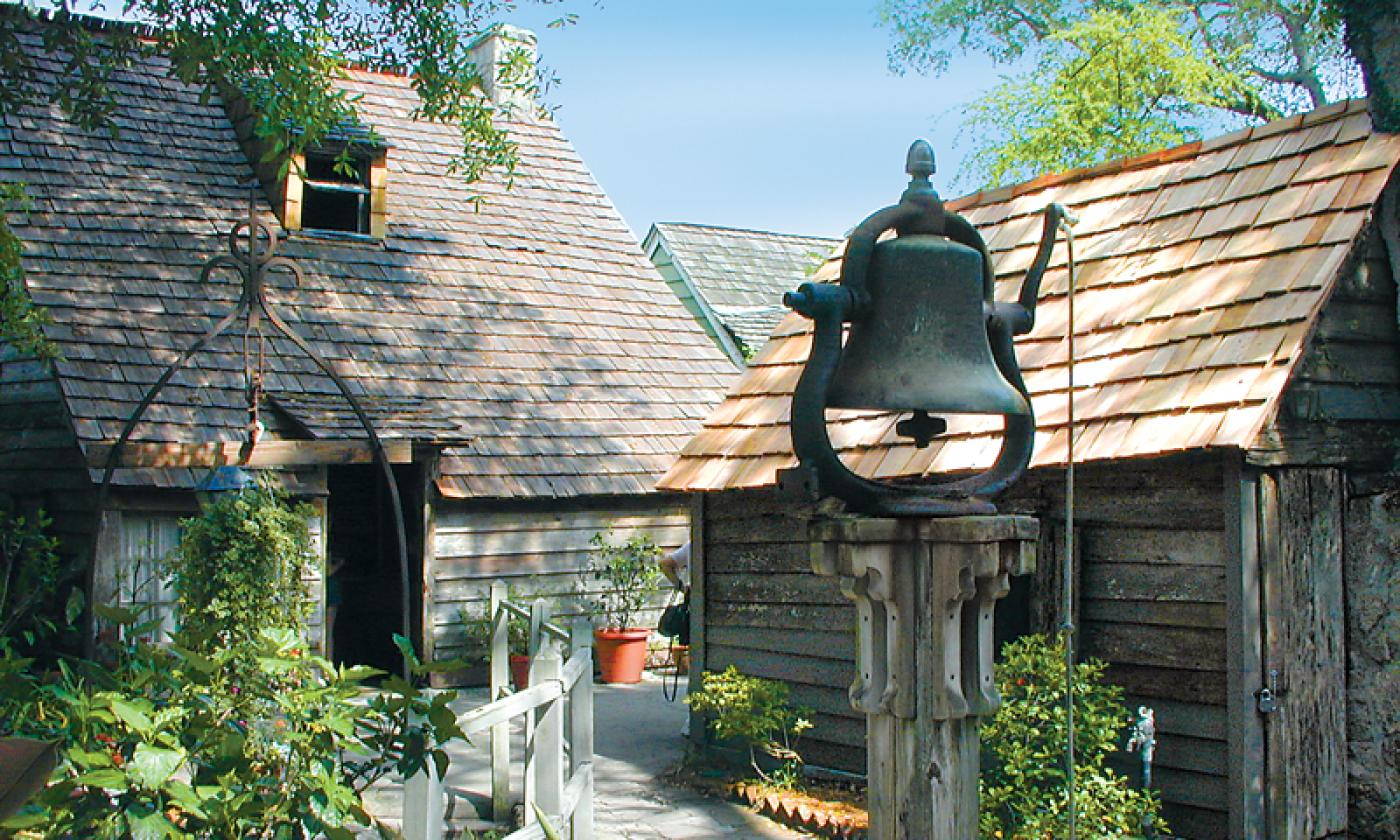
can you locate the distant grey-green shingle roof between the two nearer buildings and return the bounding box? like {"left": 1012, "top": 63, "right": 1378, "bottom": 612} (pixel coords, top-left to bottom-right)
{"left": 641, "top": 223, "right": 841, "bottom": 357}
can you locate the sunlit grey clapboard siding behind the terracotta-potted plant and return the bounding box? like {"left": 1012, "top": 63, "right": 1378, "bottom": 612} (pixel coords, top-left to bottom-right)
{"left": 426, "top": 496, "right": 690, "bottom": 659}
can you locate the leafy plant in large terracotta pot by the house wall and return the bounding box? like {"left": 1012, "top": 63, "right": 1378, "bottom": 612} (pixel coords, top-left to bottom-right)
{"left": 582, "top": 531, "right": 661, "bottom": 683}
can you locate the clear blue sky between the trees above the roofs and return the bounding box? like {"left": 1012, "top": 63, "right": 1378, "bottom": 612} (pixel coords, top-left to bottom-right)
{"left": 508, "top": 0, "right": 997, "bottom": 237}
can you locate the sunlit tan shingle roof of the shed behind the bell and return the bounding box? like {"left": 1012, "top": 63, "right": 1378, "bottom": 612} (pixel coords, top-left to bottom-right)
{"left": 661, "top": 101, "right": 1400, "bottom": 490}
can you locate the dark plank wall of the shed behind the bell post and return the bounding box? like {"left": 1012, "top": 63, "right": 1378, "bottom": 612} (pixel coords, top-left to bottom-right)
{"left": 703, "top": 456, "right": 1228, "bottom": 837}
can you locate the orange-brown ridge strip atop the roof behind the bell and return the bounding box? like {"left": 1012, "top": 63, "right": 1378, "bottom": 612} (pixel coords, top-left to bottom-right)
{"left": 946, "top": 97, "right": 1368, "bottom": 211}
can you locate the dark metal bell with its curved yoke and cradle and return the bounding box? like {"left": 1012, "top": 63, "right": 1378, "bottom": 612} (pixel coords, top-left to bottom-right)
{"left": 783, "top": 140, "right": 1065, "bottom": 517}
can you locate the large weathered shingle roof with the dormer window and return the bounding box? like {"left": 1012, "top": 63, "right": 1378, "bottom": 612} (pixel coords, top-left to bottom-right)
{"left": 0, "top": 22, "right": 734, "bottom": 497}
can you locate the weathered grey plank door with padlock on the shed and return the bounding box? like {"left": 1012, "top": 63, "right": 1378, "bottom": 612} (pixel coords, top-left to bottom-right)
{"left": 1256, "top": 469, "right": 1347, "bottom": 840}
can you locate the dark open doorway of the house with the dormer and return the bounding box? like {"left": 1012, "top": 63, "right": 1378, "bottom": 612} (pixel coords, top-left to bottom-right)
{"left": 326, "top": 463, "right": 423, "bottom": 673}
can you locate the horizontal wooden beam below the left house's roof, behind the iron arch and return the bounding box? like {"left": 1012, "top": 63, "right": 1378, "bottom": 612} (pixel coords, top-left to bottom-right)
{"left": 87, "top": 440, "right": 413, "bottom": 469}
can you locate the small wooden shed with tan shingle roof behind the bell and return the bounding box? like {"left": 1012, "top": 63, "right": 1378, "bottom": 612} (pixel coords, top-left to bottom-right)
{"left": 661, "top": 101, "right": 1400, "bottom": 839}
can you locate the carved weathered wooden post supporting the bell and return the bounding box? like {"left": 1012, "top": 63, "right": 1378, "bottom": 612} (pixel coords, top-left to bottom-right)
{"left": 809, "top": 515, "right": 1039, "bottom": 840}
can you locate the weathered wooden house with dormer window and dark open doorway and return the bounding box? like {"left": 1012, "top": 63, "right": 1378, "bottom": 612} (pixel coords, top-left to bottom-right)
{"left": 0, "top": 11, "right": 734, "bottom": 669}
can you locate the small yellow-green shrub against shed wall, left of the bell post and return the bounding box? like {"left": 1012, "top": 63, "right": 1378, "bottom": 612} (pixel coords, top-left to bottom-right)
{"left": 686, "top": 665, "right": 812, "bottom": 788}
